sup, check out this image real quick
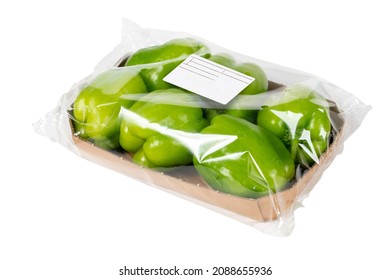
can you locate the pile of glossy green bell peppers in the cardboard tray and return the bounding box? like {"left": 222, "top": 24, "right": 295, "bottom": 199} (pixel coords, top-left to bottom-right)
{"left": 72, "top": 38, "right": 331, "bottom": 198}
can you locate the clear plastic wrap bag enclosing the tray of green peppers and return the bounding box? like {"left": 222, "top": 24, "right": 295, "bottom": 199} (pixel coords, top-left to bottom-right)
{"left": 35, "top": 20, "right": 370, "bottom": 235}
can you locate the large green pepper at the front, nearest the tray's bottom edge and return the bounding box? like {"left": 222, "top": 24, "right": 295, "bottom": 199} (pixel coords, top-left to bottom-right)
{"left": 194, "top": 114, "right": 295, "bottom": 198}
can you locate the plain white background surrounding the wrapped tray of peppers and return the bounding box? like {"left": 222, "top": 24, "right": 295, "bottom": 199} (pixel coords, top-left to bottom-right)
{"left": 0, "top": 0, "right": 390, "bottom": 280}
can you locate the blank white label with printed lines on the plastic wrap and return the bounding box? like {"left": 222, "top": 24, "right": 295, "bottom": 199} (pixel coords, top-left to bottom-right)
{"left": 164, "top": 55, "right": 255, "bottom": 104}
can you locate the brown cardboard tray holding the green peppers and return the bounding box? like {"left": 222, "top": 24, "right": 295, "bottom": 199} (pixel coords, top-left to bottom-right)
{"left": 70, "top": 91, "right": 343, "bottom": 222}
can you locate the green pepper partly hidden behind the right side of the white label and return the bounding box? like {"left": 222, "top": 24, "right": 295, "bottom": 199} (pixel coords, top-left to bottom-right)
{"left": 206, "top": 54, "right": 268, "bottom": 123}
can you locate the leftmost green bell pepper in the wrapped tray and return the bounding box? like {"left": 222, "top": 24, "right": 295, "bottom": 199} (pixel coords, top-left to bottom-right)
{"left": 73, "top": 68, "right": 146, "bottom": 149}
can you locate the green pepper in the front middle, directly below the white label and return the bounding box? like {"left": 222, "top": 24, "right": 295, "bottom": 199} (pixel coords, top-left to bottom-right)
{"left": 120, "top": 89, "right": 208, "bottom": 167}
